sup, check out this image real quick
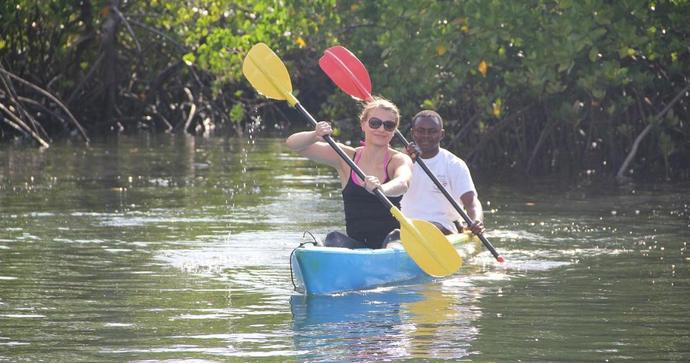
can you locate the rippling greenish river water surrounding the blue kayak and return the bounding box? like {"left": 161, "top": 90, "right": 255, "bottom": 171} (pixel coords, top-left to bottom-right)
{"left": 0, "top": 135, "right": 690, "bottom": 362}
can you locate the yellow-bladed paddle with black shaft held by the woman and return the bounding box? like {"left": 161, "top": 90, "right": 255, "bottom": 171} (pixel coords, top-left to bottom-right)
{"left": 242, "top": 43, "right": 462, "bottom": 277}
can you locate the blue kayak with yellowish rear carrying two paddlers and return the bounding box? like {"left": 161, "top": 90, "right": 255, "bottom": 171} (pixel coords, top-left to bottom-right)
{"left": 290, "top": 233, "right": 481, "bottom": 295}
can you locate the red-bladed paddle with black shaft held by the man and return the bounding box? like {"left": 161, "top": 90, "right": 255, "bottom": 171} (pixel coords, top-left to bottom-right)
{"left": 319, "top": 45, "right": 504, "bottom": 263}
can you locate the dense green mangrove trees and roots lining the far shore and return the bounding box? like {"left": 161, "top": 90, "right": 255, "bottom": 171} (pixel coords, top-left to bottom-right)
{"left": 0, "top": 0, "right": 690, "bottom": 182}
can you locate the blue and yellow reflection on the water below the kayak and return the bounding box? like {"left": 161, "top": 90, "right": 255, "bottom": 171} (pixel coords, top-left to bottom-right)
{"left": 290, "top": 284, "right": 481, "bottom": 361}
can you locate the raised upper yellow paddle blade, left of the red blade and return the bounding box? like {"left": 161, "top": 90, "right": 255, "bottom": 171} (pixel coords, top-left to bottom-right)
{"left": 242, "top": 43, "right": 297, "bottom": 107}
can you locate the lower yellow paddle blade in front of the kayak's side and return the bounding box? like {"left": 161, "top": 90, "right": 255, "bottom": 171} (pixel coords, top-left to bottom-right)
{"left": 390, "top": 207, "right": 462, "bottom": 277}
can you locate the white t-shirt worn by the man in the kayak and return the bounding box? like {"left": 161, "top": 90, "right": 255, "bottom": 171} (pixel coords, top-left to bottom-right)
{"left": 400, "top": 148, "right": 477, "bottom": 232}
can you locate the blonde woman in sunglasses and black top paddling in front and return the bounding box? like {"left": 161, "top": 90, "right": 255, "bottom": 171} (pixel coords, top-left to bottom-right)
{"left": 287, "top": 98, "right": 412, "bottom": 248}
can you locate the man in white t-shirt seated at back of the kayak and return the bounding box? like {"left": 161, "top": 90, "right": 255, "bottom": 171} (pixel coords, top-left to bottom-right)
{"left": 401, "top": 110, "right": 484, "bottom": 234}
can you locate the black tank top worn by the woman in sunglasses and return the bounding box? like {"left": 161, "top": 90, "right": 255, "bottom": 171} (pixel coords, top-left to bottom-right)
{"left": 342, "top": 152, "right": 402, "bottom": 249}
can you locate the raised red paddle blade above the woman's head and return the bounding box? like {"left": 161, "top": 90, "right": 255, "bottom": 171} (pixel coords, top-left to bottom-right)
{"left": 319, "top": 45, "right": 372, "bottom": 101}
